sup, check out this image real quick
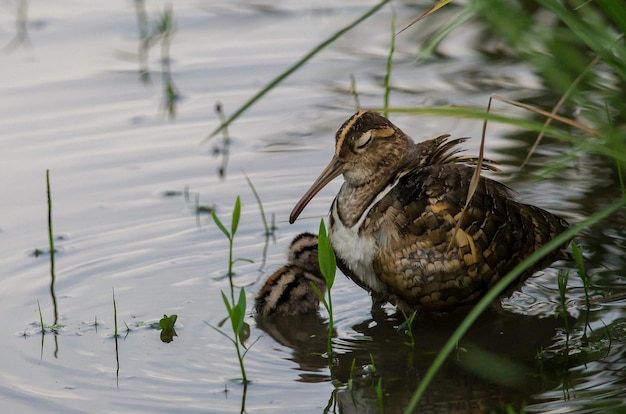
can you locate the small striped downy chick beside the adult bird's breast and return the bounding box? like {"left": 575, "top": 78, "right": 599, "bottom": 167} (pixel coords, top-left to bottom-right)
{"left": 254, "top": 233, "right": 326, "bottom": 317}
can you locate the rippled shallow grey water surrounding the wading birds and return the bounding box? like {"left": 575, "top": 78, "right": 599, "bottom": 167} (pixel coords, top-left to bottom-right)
{"left": 0, "top": 0, "right": 626, "bottom": 413}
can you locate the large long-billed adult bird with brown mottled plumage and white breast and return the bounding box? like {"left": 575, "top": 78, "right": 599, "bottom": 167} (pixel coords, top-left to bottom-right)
{"left": 289, "top": 111, "right": 568, "bottom": 311}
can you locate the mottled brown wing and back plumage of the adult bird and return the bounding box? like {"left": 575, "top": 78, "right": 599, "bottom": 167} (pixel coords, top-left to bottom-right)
{"left": 361, "top": 141, "right": 567, "bottom": 311}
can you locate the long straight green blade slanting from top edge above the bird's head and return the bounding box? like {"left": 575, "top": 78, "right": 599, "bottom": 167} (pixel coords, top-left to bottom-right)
{"left": 203, "top": 0, "right": 391, "bottom": 142}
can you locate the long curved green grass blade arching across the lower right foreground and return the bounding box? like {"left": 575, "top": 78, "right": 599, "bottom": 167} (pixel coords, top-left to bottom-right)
{"left": 404, "top": 198, "right": 626, "bottom": 414}
